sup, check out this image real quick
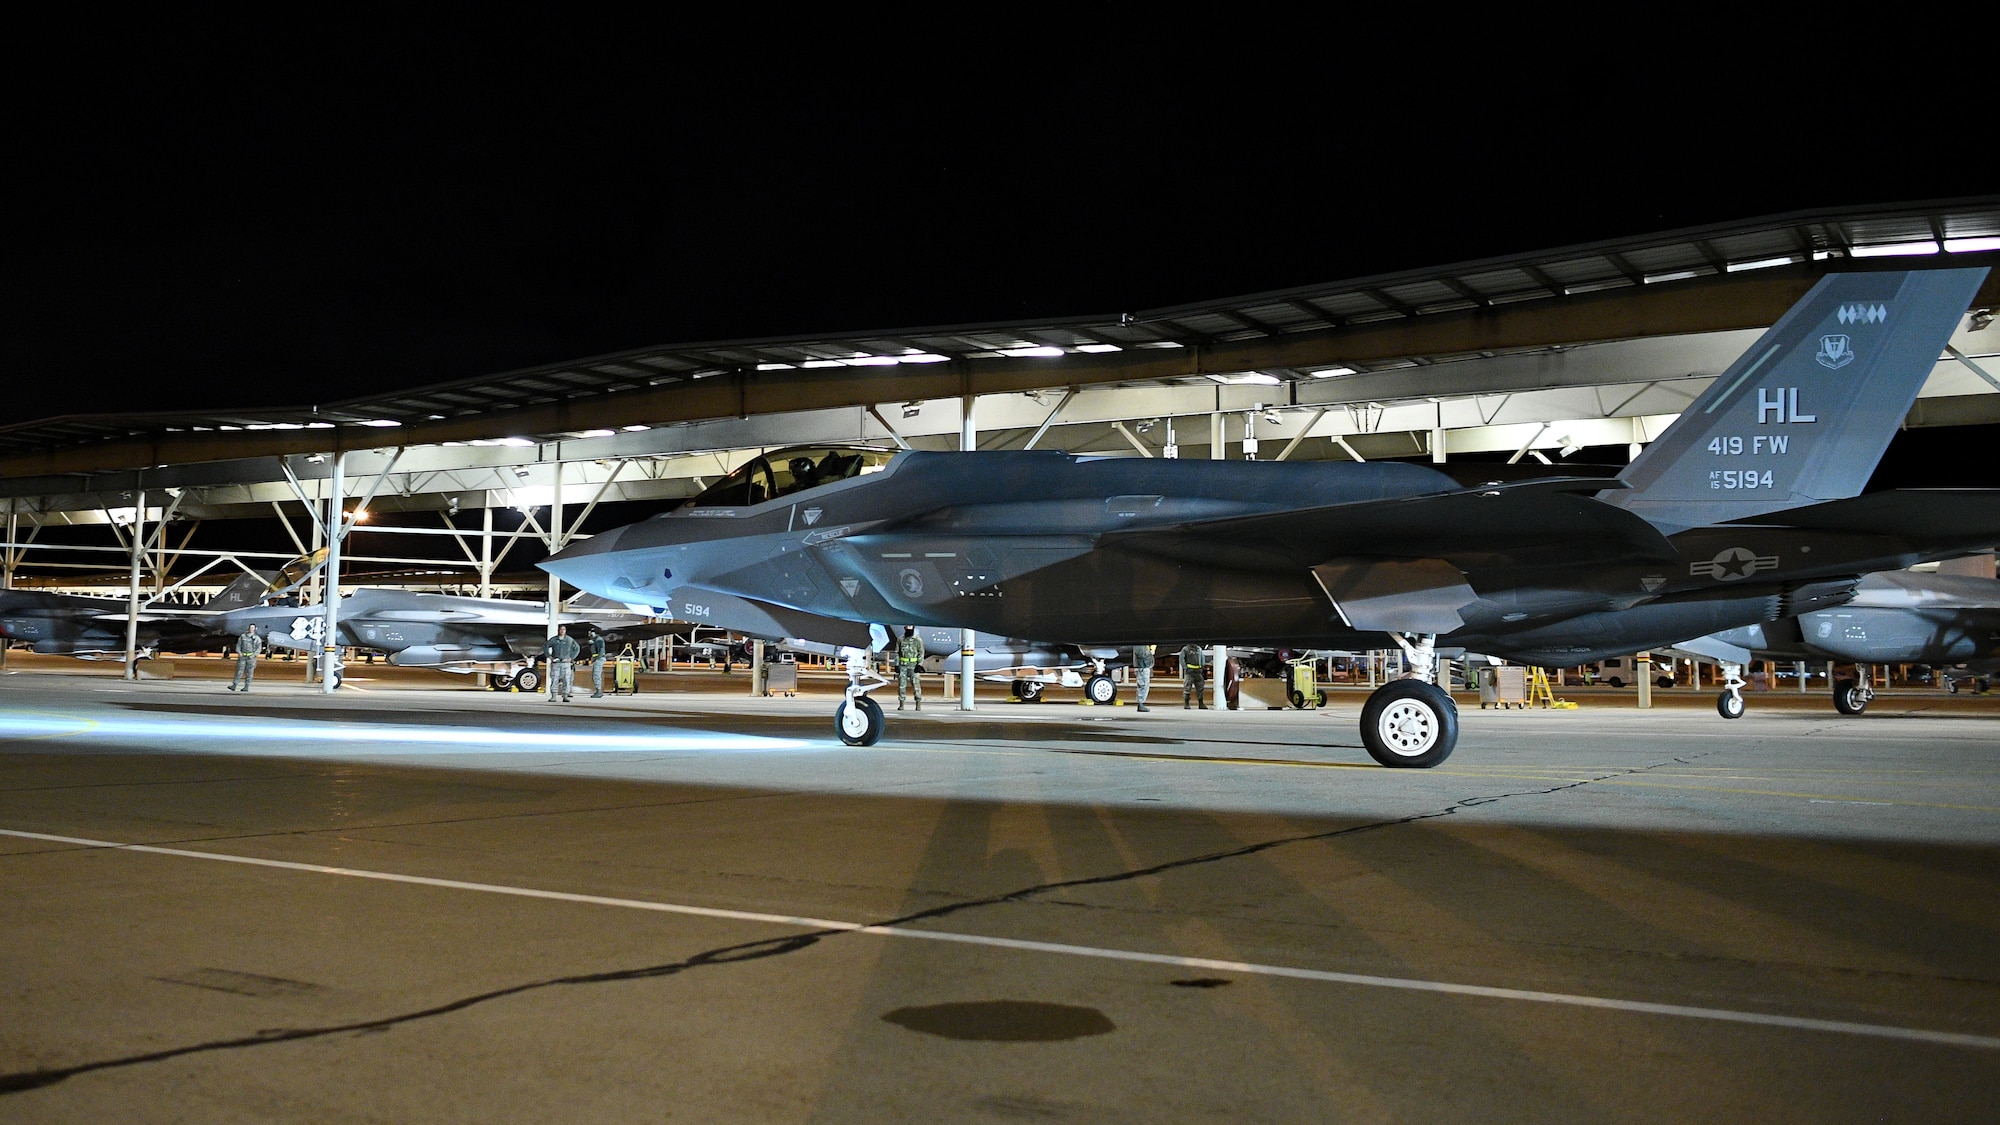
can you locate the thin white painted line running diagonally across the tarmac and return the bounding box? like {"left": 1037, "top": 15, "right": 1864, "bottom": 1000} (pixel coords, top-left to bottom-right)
{"left": 15, "top": 829, "right": 2000, "bottom": 1051}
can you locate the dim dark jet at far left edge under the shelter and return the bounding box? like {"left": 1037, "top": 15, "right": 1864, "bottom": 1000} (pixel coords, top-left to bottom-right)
{"left": 0, "top": 575, "right": 280, "bottom": 661}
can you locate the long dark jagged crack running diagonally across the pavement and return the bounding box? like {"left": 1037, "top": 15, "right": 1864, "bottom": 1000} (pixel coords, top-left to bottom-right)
{"left": 0, "top": 747, "right": 1734, "bottom": 1097}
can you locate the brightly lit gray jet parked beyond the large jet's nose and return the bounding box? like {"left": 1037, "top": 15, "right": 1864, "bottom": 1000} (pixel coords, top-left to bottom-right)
{"left": 218, "top": 589, "right": 674, "bottom": 691}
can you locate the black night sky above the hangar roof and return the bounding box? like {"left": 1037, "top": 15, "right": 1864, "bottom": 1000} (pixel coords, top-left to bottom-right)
{"left": 0, "top": 26, "right": 1994, "bottom": 424}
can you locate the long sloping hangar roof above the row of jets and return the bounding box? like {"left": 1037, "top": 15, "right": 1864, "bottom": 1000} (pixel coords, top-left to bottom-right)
{"left": 0, "top": 196, "right": 2000, "bottom": 476}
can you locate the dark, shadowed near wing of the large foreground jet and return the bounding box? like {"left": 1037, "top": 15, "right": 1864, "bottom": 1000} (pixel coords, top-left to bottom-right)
{"left": 1100, "top": 476, "right": 1678, "bottom": 569}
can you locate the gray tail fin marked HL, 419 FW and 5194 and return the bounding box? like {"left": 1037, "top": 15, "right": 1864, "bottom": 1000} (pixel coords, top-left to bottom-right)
{"left": 1600, "top": 268, "right": 1986, "bottom": 534}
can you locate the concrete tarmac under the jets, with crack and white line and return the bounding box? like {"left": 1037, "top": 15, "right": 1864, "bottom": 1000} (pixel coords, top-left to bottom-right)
{"left": 0, "top": 655, "right": 2000, "bottom": 1123}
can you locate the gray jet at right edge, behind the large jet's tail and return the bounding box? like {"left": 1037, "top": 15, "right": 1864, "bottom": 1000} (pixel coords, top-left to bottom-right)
{"left": 1674, "top": 571, "right": 2000, "bottom": 719}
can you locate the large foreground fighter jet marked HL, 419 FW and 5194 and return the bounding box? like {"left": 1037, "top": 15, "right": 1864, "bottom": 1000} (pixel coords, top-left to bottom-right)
{"left": 542, "top": 268, "right": 2000, "bottom": 767}
